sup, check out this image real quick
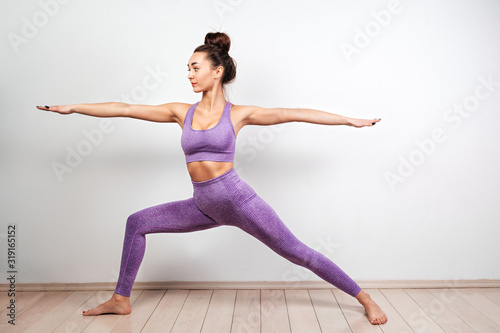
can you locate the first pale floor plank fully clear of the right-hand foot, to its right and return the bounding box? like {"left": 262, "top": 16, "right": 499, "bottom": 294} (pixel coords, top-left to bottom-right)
{"left": 380, "top": 289, "right": 444, "bottom": 333}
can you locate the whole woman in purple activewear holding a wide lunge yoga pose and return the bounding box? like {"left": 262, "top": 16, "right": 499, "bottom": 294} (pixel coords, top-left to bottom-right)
{"left": 38, "top": 32, "right": 387, "bottom": 324}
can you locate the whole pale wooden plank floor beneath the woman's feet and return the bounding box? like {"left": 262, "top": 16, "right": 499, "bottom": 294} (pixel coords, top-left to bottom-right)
{"left": 0, "top": 288, "right": 500, "bottom": 333}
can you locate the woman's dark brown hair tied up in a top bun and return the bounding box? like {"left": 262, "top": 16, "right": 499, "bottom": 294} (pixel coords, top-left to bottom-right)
{"left": 194, "top": 32, "right": 236, "bottom": 87}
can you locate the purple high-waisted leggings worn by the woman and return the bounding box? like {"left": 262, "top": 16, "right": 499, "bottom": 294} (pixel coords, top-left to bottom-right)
{"left": 115, "top": 169, "right": 361, "bottom": 297}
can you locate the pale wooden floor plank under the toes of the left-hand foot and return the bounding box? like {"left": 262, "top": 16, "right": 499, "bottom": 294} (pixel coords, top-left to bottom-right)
{"left": 52, "top": 291, "right": 113, "bottom": 333}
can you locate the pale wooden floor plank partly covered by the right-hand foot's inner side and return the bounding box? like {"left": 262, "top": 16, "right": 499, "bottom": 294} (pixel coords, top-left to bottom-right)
{"left": 332, "top": 289, "right": 382, "bottom": 333}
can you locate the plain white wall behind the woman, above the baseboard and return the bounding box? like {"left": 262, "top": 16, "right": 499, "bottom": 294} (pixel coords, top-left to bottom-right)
{"left": 0, "top": 0, "right": 500, "bottom": 283}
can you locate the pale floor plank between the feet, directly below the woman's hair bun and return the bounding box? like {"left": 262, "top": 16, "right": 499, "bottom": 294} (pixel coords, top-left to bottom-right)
{"left": 201, "top": 290, "right": 236, "bottom": 333}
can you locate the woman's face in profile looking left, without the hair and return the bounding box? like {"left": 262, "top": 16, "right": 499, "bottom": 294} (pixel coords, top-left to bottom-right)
{"left": 188, "top": 52, "right": 222, "bottom": 92}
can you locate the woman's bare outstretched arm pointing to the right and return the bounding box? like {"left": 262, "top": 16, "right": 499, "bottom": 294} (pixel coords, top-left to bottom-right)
{"left": 241, "top": 106, "right": 380, "bottom": 127}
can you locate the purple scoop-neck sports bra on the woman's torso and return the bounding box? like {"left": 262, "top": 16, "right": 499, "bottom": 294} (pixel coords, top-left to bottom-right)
{"left": 181, "top": 101, "right": 236, "bottom": 163}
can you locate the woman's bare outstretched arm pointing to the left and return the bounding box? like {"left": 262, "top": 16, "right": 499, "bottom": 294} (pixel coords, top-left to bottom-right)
{"left": 37, "top": 102, "right": 189, "bottom": 125}
